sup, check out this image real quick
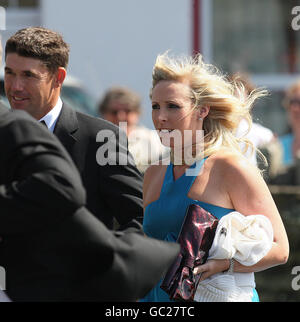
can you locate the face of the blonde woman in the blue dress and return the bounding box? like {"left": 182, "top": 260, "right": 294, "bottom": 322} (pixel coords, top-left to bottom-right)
{"left": 152, "top": 81, "right": 202, "bottom": 148}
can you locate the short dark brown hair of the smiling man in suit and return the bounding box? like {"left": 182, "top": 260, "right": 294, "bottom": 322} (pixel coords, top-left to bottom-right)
{"left": 5, "top": 27, "right": 70, "bottom": 72}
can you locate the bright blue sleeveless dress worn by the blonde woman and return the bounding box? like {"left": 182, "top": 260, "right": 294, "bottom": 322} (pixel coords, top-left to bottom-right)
{"left": 140, "top": 158, "right": 258, "bottom": 302}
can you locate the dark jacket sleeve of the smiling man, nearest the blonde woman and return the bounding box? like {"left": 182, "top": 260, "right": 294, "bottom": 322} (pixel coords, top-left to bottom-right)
{"left": 99, "top": 127, "right": 143, "bottom": 231}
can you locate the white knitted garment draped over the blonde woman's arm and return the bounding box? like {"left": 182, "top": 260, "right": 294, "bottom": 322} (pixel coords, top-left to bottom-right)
{"left": 194, "top": 211, "right": 273, "bottom": 302}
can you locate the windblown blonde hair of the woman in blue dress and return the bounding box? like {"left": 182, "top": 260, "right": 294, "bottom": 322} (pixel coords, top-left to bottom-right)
{"left": 150, "top": 52, "right": 267, "bottom": 161}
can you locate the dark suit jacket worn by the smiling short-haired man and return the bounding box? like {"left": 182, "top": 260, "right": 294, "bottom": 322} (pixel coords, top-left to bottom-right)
{"left": 54, "top": 104, "right": 143, "bottom": 228}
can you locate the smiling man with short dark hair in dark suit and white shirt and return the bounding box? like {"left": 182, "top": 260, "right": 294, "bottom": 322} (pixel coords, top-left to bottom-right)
{"left": 5, "top": 27, "right": 143, "bottom": 228}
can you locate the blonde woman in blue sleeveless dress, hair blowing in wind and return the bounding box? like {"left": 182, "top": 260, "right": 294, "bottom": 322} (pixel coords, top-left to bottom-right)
{"left": 143, "top": 53, "right": 289, "bottom": 301}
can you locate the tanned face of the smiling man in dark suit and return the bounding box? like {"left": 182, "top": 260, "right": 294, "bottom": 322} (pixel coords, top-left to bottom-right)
{"left": 4, "top": 53, "right": 59, "bottom": 120}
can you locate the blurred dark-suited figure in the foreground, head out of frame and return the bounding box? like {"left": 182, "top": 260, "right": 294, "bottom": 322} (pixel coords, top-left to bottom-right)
{"left": 0, "top": 106, "right": 178, "bottom": 301}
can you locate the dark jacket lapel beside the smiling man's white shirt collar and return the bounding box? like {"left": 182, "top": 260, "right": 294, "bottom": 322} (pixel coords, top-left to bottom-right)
{"left": 54, "top": 104, "right": 78, "bottom": 151}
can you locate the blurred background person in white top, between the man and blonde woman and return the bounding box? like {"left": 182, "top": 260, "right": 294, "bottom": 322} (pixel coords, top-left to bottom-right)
{"left": 98, "top": 87, "right": 168, "bottom": 173}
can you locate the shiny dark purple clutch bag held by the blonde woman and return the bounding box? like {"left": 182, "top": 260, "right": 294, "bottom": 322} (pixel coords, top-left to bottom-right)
{"left": 160, "top": 204, "right": 218, "bottom": 301}
